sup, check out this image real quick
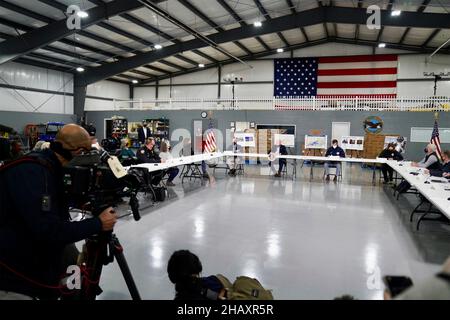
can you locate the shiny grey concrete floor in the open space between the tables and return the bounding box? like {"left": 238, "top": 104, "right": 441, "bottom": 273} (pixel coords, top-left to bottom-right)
{"left": 95, "top": 165, "right": 450, "bottom": 299}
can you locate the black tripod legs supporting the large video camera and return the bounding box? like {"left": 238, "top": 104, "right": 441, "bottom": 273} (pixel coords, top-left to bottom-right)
{"left": 79, "top": 232, "right": 141, "bottom": 300}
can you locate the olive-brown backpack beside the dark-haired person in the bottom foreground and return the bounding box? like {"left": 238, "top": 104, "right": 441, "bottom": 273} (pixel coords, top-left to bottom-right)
{"left": 216, "top": 274, "right": 273, "bottom": 300}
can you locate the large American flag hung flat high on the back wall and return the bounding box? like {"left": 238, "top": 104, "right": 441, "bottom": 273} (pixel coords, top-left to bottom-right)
{"left": 274, "top": 54, "right": 398, "bottom": 98}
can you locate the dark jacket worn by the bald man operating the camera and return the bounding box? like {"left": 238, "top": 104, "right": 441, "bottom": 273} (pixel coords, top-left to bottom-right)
{"left": 0, "top": 150, "right": 101, "bottom": 298}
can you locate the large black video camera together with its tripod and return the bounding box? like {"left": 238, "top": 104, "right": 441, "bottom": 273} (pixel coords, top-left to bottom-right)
{"left": 60, "top": 150, "right": 145, "bottom": 300}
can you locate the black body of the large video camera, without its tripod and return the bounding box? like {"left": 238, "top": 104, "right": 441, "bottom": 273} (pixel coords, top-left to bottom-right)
{"left": 63, "top": 151, "right": 141, "bottom": 221}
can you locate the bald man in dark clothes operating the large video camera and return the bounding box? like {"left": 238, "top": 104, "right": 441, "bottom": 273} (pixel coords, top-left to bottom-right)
{"left": 0, "top": 124, "right": 116, "bottom": 299}
